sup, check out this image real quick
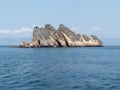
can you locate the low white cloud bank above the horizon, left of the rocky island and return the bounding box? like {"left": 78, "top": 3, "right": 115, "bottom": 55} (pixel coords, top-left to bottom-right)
{"left": 0, "top": 28, "right": 33, "bottom": 45}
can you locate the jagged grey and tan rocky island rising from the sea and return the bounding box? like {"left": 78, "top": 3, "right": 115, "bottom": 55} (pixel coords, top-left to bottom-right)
{"left": 20, "top": 24, "right": 103, "bottom": 47}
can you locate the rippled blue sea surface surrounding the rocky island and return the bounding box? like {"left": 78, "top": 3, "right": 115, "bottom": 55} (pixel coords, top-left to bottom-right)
{"left": 0, "top": 46, "right": 120, "bottom": 90}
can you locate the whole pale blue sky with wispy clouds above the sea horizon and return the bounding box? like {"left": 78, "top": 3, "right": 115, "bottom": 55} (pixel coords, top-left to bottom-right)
{"left": 0, "top": 0, "right": 120, "bottom": 45}
